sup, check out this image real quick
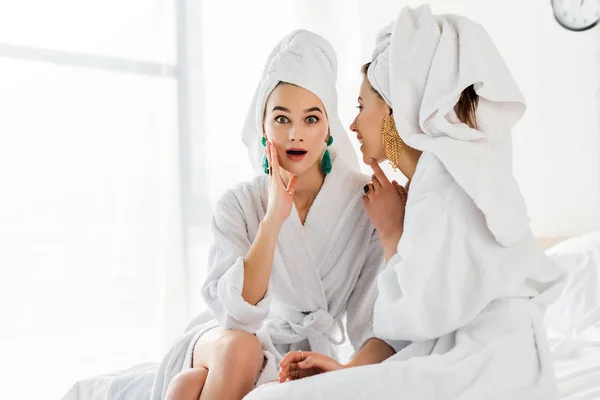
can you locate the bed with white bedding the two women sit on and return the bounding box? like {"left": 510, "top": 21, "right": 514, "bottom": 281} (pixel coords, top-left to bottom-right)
{"left": 63, "top": 232, "right": 600, "bottom": 400}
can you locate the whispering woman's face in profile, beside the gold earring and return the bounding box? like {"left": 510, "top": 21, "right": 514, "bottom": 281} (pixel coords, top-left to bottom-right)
{"left": 350, "top": 78, "right": 391, "bottom": 164}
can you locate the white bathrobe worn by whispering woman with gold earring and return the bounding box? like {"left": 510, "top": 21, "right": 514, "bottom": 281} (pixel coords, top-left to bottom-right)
{"left": 246, "top": 153, "right": 562, "bottom": 400}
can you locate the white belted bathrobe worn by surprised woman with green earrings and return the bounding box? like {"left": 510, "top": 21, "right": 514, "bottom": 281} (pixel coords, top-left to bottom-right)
{"left": 152, "top": 158, "right": 383, "bottom": 399}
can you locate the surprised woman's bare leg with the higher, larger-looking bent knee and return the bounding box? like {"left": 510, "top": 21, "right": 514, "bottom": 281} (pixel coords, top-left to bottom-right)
{"left": 193, "top": 328, "right": 264, "bottom": 400}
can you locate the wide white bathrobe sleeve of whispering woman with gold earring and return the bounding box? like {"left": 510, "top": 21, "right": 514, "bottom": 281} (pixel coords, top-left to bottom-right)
{"left": 374, "top": 188, "right": 528, "bottom": 341}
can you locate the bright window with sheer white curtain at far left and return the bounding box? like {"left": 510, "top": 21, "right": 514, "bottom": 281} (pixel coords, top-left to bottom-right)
{"left": 0, "top": 0, "right": 184, "bottom": 399}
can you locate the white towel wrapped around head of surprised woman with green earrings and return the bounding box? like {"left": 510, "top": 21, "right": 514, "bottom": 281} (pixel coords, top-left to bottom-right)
{"left": 242, "top": 30, "right": 358, "bottom": 174}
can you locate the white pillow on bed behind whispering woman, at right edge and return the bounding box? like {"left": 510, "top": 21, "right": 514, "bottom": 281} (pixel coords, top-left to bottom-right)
{"left": 544, "top": 232, "right": 600, "bottom": 340}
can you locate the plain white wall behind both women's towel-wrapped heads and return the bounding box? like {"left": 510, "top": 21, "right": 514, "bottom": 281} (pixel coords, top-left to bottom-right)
{"left": 189, "top": 0, "right": 600, "bottom": 312}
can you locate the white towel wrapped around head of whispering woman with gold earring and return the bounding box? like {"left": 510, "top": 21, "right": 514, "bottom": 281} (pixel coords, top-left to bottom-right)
{"left": 367, "top": 5, "right": 529, "bottom": 246}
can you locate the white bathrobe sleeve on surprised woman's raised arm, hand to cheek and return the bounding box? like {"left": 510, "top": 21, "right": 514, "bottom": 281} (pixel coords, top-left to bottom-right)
{"left": 202, "top": 191, "right": 271, "bottom": 333}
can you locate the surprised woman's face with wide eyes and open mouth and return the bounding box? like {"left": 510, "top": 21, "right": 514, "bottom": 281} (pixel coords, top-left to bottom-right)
{"left": 263, "top": 84, "right": 329, "bottom": 176}
